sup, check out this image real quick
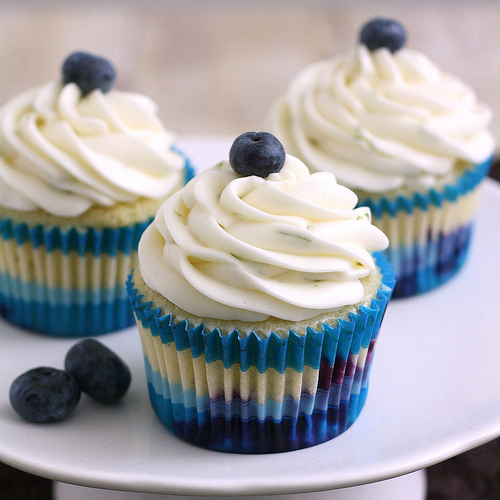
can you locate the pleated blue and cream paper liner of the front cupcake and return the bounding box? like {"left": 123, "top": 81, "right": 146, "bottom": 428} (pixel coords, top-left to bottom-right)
{"left": 127, "top": 255, "right": 394, "bottom": 453}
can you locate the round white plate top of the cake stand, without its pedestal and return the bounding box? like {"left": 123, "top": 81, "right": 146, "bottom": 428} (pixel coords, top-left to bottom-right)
{"left": 0, "top": 138, "right": 500, "bottom": 495}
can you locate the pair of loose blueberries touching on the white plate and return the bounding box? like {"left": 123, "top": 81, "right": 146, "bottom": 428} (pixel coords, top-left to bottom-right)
{"left": 9, "top": 338, "right": 131, "bottom": 423}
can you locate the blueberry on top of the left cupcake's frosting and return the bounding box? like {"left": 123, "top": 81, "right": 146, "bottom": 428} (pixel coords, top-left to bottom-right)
{"left": 62, "top": 52, "right": 116, "bottom": 96}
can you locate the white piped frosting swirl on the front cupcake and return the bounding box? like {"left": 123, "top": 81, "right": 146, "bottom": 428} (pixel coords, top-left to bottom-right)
{"left": 139, "top": 155, "right": 388, "bottom": 321}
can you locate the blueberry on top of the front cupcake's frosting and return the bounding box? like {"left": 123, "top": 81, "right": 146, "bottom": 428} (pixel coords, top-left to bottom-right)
{"left": 229, "top": 132, "right": 285, "bottom": 177}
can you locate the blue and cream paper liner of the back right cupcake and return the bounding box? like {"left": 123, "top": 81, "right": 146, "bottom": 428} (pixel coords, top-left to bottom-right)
{"left": 358, "top": 158, "right": 491, "bottom": 298}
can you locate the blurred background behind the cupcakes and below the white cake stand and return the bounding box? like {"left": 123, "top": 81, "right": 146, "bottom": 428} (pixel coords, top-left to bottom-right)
{"left": 0, "top": 0, "right": 500, "bottom": 500}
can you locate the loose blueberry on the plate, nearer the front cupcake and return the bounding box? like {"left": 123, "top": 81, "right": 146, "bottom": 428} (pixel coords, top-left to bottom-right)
{"left": 64, "top": 339, "right": 131, "bottom": 404}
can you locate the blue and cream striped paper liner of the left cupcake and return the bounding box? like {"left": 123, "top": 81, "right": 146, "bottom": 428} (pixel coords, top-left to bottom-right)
{"left": 0, "top": 150, "right": 194, "bottom": 337}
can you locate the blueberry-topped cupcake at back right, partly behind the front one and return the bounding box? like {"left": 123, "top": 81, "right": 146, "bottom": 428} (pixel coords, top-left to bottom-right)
{"left": 268, "top": 19, "right": 494, "bottom": 297}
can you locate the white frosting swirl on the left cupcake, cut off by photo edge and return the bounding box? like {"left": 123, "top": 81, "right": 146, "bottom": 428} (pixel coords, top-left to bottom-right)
{"left": 0, "top": 82, "right": 184, "bottom": 217}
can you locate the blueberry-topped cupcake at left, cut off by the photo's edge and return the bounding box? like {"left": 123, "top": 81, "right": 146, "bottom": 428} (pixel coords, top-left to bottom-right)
{"left": 0, "top": 52, "right": 192, "bottom": 336}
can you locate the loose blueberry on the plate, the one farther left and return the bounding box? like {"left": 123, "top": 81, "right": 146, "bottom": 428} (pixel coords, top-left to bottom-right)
{"left": 9, "top": 366, "right": 81, "bottom": 422}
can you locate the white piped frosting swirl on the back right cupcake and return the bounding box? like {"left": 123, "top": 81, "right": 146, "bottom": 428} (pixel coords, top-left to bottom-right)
{"left": 269, "top": 45, "right": 494, "bottom": 193}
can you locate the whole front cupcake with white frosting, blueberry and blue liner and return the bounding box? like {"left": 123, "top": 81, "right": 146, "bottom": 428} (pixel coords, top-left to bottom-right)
{"left": 127, "top": 132, "right": 394, "bottom": 453}
